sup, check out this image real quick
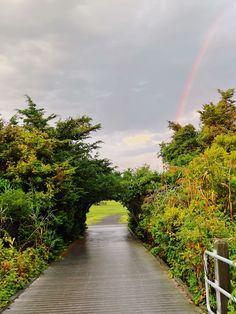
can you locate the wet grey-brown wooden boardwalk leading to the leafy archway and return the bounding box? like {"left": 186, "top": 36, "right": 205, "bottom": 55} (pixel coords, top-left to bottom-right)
{"left": 4, "top": 221, "right": 199, "bottom": 314}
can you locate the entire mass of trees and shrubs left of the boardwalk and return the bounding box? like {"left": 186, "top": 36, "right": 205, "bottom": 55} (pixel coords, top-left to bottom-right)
{"left": 0, "top": 97, "right": 119, "bottom": 306}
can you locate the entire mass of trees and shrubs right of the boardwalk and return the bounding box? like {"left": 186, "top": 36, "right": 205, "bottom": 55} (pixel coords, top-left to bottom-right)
{"left": 123, "top": 90, "right": 236, "bottom": 313}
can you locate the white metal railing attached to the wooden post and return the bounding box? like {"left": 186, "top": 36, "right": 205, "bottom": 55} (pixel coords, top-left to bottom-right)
{"left": 204, "top": 251, "right": 236, "bottom": 314}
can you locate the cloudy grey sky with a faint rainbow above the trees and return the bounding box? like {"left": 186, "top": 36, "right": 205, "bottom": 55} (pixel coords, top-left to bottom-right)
{"left": 0, "top": 0, "right": 236, "bottom": 169}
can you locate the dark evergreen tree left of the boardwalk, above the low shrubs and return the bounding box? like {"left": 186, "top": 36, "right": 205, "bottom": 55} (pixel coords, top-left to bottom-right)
{"left": 0, "top": 97, "right": 119, "bottom": 244}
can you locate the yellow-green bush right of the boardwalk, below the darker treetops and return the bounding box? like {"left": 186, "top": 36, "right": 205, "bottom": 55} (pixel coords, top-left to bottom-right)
{"left": 124, "top": 135, "right": 236, "bottom": 308}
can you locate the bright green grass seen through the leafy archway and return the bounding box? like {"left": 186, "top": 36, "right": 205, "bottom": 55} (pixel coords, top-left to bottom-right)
{"left": 87, "top": 201, "right": 128, "bottom": 225}
